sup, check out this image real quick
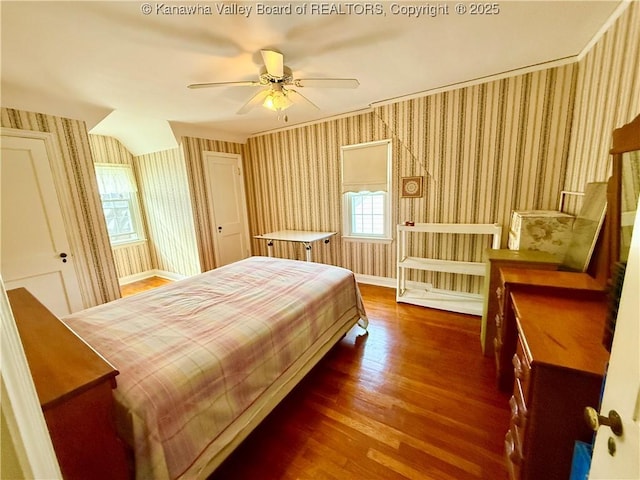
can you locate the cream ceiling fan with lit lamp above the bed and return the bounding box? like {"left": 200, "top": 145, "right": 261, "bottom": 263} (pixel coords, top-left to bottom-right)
{"left": 188, "top": 50, "right": 360, "bottom": 114}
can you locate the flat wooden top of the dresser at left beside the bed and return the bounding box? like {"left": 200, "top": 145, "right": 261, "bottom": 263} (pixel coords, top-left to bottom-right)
{"left": 7, "top": 288, "right": 118, "bottom": 409}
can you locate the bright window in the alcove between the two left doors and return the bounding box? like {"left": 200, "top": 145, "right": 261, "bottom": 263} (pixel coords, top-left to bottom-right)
{"left": 95, "top": 164, "right": 144, "bottom": 246}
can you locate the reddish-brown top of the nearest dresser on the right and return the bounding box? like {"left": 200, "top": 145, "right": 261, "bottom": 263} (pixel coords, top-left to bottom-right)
{"left": 511, "top": 290, "right": 609, "bottom": 376}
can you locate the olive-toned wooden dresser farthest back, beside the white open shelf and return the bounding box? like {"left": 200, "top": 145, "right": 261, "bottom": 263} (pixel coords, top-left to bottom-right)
{"left": 480, "top": 249, "right": 560, "bottom": 357}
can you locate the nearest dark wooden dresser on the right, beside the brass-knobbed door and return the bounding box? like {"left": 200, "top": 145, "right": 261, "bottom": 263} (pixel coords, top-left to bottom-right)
{"left": 505, "top": 289, "right": 609, "bottom": 480}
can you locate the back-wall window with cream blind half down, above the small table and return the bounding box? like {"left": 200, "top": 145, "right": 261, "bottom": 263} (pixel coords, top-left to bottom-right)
{"left": 342, "top": 140, "right": 391, "bottom": 241}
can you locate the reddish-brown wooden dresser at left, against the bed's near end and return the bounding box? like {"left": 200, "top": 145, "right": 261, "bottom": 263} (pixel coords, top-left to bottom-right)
{"left": 7, "top": 288, "right": 130, "bottom": 480}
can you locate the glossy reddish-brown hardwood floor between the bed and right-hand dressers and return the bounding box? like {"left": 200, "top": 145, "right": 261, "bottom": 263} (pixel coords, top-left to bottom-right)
{"left": 209, "top": 285, "right": 509, "bottom": 480}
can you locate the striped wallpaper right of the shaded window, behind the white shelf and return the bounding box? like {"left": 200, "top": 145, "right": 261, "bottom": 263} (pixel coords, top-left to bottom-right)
{"left": 380, "top": 65, "right": 576, "bottom": 292}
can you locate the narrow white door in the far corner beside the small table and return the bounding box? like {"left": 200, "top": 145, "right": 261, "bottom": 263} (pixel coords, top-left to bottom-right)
{"left": 204, "top": 152, "right": 250, "bottom": 267}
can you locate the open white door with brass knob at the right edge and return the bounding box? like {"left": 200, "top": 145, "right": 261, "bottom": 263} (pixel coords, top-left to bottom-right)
{"left": 589, "top": 205, "right": 640, "bottom": 480}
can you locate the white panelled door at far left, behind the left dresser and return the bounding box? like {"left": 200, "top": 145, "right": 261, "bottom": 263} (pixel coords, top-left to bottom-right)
{"left": 0, "top": 130, "right": 83, "bottom": 316}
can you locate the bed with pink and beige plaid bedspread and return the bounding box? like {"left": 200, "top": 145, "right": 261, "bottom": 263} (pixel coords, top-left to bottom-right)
{"left": 62, "top": 257, "right": 368, "bottom": 480}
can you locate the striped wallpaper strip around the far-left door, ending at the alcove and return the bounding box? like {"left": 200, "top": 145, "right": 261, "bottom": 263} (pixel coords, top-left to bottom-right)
{"left": 0, "top": 108, "right": 120, "bottom": 307}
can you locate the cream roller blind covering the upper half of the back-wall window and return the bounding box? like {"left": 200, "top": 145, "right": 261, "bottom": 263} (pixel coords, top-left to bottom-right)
{"left": 342, "top": 142, "right": 389, "bottom": 193}
